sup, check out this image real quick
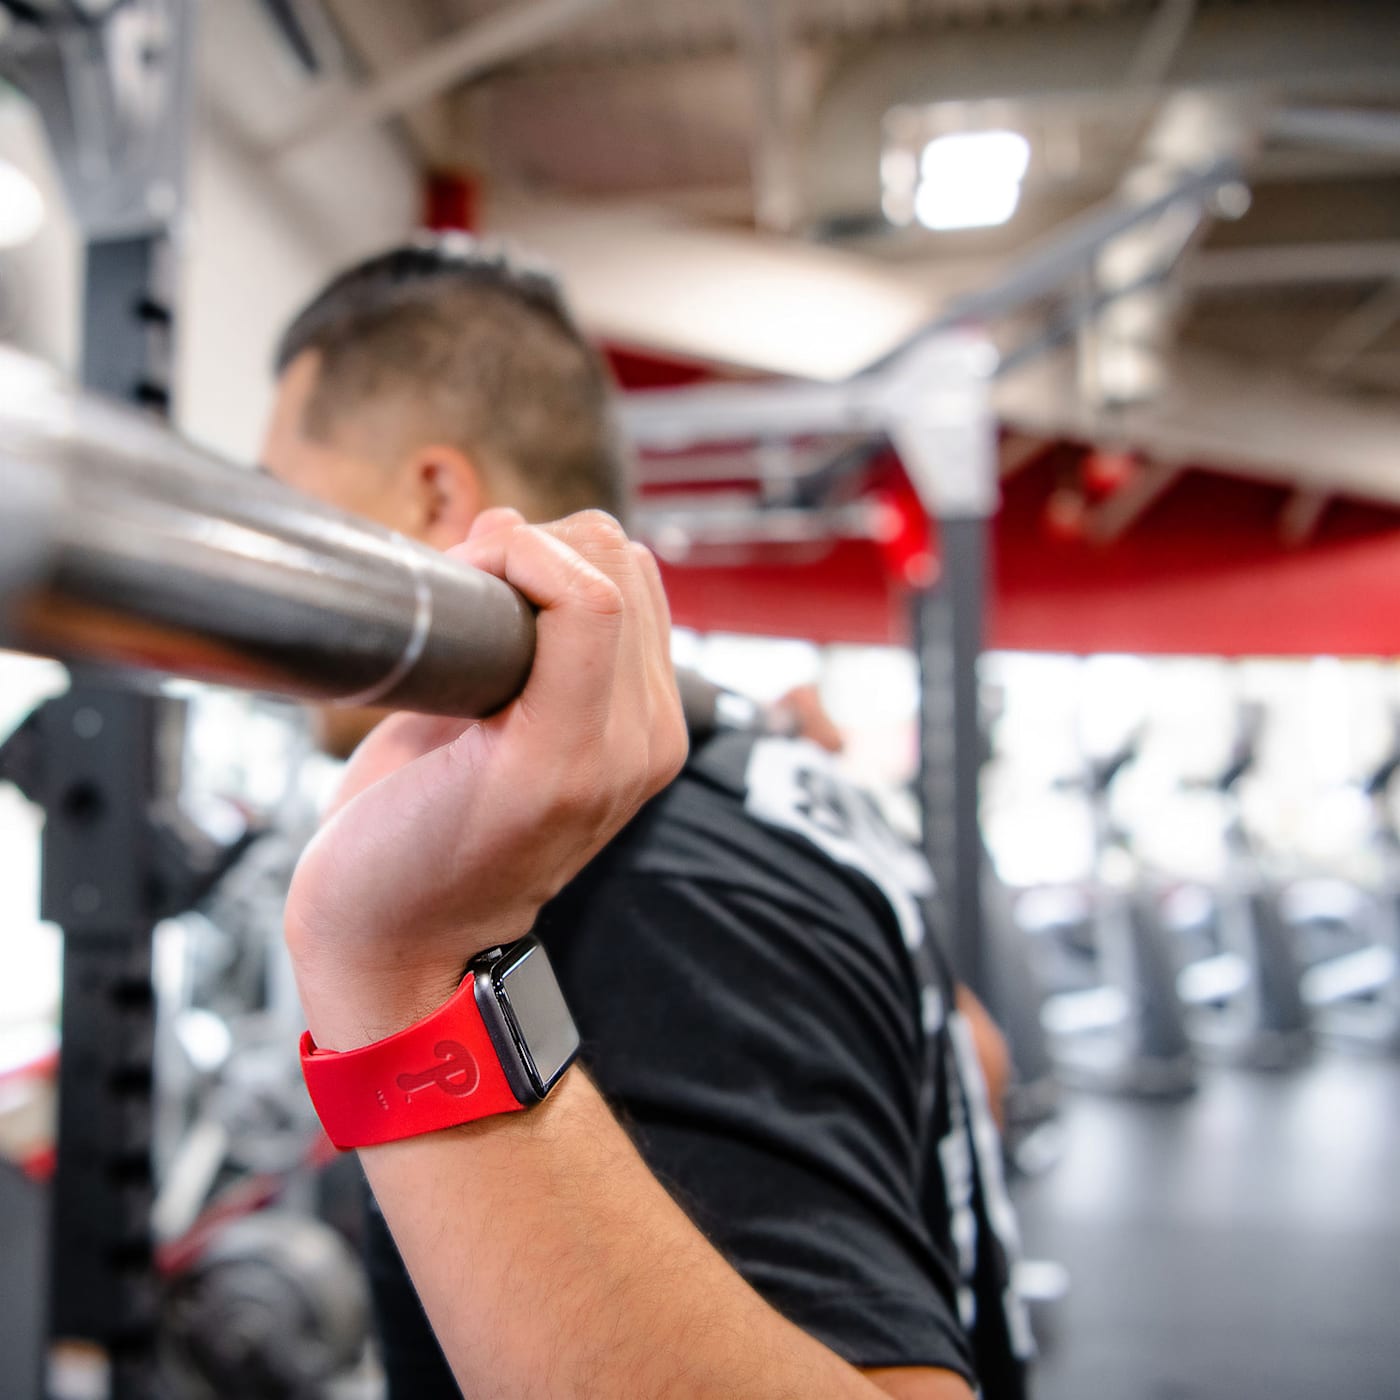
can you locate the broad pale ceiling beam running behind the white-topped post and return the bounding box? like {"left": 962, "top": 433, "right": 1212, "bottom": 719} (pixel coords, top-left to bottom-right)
{"left": 491, "top": 199, "right": 1400, "bottom": 504}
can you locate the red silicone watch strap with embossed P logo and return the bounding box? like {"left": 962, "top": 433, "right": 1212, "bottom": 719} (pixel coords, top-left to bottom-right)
{"left": 301, "top": 973, "right": 524, "bottom": 1149}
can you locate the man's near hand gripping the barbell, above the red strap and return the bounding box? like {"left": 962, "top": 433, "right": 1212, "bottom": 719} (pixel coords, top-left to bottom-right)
{"left": 286, "top": 510, "right": 686, "bottom": 1050}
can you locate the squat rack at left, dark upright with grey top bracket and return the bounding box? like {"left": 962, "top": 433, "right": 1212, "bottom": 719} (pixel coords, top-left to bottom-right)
{"left": 0, "top": 0, "right": 200, "bottom": 1400}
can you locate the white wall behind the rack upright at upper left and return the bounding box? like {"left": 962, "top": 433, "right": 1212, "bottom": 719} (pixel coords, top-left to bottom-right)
{"left": 0, "top": 0, "right": 419, "bottom": 461}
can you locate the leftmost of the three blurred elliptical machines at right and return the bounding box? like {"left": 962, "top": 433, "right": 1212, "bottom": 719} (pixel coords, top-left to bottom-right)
{"left": 1040, "top": 735, "right": 1196, "bottom": 1098}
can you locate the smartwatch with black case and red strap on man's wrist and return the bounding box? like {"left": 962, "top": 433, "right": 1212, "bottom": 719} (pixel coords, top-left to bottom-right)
{"left": 301, "top": 935, "right": 578, "bottom": 1149}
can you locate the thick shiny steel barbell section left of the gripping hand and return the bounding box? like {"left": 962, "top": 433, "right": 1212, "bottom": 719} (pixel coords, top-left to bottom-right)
{"left": 0, "top": 350, "right": 535, "bottom": 717}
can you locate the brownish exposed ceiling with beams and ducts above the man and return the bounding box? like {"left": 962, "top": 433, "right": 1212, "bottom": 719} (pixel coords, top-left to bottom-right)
{"left": 273, "top": 0, "right": 1400, "bottom": 500}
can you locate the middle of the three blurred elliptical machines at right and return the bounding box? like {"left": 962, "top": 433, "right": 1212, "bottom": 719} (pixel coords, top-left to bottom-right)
{"left": 1179, "top": 703, "right": 1312, "bottom": 1070}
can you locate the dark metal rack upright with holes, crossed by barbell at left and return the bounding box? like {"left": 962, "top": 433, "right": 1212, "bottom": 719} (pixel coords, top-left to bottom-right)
{"left": 50, "top": 231, "right": 185, "bottom": 1400}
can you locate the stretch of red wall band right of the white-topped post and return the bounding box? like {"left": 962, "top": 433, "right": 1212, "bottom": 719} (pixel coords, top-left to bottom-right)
{"left": 991, "top": 458, "right": 1400, "bottom": 655}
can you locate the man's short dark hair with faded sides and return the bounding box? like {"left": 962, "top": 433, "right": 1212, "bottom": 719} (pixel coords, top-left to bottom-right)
{"left": 276, "top": 234, "right": 629, "bottom": 517}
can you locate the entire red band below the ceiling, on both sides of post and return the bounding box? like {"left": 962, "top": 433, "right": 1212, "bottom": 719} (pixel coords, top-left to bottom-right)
{"left": 612, "top": 351, "right": 1400, "bottom": 655}
